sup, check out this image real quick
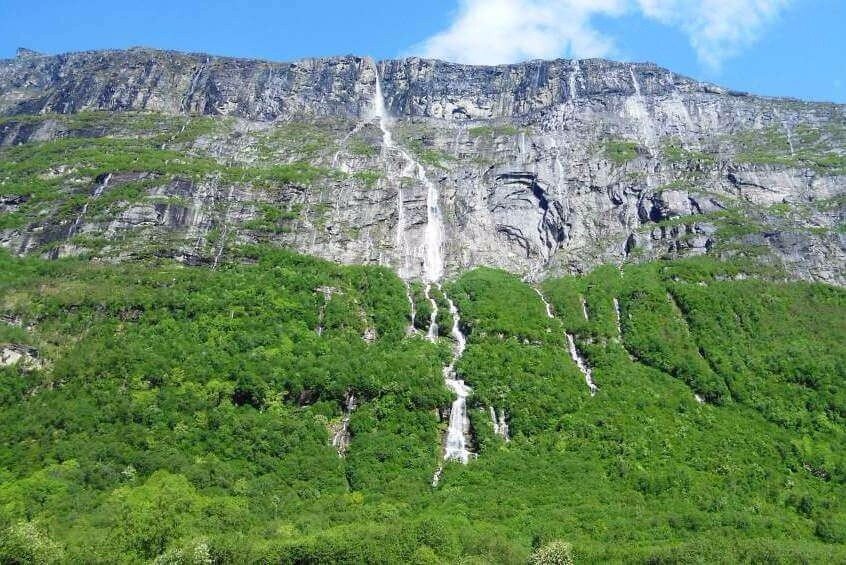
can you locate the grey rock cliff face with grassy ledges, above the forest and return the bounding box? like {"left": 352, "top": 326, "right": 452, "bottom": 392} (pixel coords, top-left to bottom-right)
{"left": 0, "top": 49, "right": 846, "bottom": 284}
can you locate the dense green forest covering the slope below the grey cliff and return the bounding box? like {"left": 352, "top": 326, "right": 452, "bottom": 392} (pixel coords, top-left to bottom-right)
{"left": 0, "top": 246, "right": 846, "bottom": 564}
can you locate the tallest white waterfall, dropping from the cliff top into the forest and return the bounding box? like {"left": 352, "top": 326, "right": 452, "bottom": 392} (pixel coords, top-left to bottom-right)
{"left": 373, "top": 64, "right": 472, "bottom": 476}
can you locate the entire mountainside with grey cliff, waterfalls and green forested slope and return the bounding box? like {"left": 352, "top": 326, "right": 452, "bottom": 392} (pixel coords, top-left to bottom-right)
{"left": 0, "top": 49, "right": 846, "bottom": 564}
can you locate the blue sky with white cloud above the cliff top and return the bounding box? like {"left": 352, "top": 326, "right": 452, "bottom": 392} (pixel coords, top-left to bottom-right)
{"left": 0, "top": 0, "right": 846, "bottom": 102}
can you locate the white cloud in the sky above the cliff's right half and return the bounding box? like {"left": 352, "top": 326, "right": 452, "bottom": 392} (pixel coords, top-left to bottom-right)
{"left": 414, "top": 0, "right": 793, "bottom": 69}
